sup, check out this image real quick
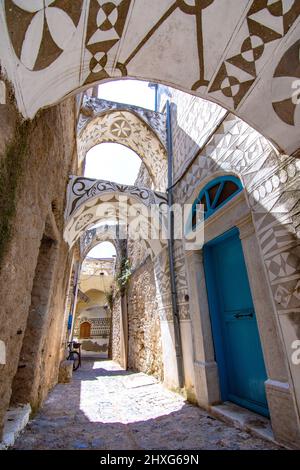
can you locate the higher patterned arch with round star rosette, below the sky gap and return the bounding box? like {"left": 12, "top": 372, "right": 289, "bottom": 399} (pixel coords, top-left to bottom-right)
{"left": 77, "top": 96, "right": 167, "bottom": 191}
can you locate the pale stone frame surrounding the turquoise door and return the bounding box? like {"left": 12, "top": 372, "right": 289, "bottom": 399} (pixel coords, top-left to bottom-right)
{"left": 185, "top": 185, "right": 294, "bottom": 435}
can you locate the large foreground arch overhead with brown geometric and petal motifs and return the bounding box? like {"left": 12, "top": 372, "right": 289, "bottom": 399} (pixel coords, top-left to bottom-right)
{"left": 0, "top": 0, "right": 300, "bottom": 153}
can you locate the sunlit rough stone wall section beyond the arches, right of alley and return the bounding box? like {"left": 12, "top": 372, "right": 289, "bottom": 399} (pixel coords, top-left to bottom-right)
{"left": 128, "top": 258, "right": 163, "bottom": 379}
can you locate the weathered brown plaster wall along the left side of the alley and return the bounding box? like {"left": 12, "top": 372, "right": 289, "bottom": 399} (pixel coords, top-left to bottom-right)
{"left": 0, "top": 81, "right": 76, "bottom": 431}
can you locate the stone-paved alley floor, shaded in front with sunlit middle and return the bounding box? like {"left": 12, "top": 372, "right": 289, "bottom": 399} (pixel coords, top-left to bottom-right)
{"left": 14, "top": 360, "right": 277, "bottom": 450}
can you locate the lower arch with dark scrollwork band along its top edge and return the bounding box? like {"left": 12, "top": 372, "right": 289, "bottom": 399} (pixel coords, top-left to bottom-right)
{"left": 64, "top": 176, "right": 167, "bottom": 254}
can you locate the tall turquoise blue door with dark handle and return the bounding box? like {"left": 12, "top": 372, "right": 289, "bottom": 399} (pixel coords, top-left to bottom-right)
{"left": 204, "top": 228, "right": 268, "bottom": 416}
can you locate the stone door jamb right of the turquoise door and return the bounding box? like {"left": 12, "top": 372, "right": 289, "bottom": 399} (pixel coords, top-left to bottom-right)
{"left": 237, "top": 214, "right": 300, "bottom": 444}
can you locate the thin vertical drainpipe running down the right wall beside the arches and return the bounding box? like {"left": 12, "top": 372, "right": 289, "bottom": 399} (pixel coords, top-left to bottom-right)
{"left": 166, "top": 100, "right": 184, "bottom": 388}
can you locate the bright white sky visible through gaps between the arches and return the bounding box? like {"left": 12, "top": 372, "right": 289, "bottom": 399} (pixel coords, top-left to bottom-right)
{"left": 85, "top": 80, "right": 155, "bottom": 258}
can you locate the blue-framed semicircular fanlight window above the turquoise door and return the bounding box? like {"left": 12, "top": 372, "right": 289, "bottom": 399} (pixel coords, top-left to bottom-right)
{"left": 192, "top": 176, "right": 243, "bottom": 227}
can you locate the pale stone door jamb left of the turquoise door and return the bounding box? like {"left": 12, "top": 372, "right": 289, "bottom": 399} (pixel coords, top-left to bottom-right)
{"left": 185, "top": 250, "right": 220, "bottom": 407}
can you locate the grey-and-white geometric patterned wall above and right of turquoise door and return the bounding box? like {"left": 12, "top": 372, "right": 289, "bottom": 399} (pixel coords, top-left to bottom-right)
{"left": 171, "top": 98, "right": 300, "bottom": 348}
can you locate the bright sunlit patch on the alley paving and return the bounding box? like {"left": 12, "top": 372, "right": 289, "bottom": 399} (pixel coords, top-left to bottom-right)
{"left": 80, "top": 361, "right": 185, "bottom": 424}
